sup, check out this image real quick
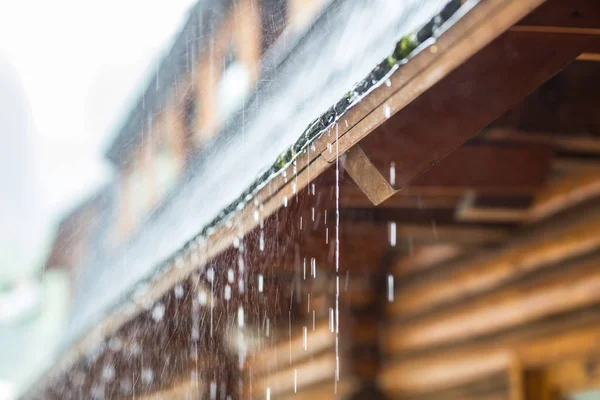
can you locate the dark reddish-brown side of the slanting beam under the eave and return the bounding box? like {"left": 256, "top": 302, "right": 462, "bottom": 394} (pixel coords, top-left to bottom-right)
{"left": 354, "top": 32, "right": 585, "bottom": 194}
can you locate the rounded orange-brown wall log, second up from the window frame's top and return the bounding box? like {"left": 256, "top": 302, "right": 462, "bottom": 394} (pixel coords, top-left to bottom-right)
{"left": 386, "top": 258, "right": 600, "bottom": 351}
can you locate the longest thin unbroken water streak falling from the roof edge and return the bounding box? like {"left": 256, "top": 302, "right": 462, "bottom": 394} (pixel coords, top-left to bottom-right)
{"left": 334, "top": 124, "right": 340, "bottom": 394}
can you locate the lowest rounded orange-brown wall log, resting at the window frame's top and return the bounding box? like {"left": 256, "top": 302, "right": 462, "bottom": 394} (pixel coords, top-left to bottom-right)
{"left": 380, "top": 314, "right": 600, "bottom": 395}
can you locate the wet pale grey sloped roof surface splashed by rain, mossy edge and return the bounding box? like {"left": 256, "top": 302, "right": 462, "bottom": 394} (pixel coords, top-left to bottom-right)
{"left": 65, "top": 0, "right": 460, "bottom": 352}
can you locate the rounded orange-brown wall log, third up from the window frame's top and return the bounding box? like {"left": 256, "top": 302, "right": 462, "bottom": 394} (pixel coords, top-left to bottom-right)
{"left": 390, "top": 206, "right": 600, "bottom": 317}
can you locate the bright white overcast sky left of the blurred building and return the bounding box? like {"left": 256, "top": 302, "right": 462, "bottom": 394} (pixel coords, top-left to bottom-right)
{"left": 0, "top": 0, "right": 194, "bottom": 231}
